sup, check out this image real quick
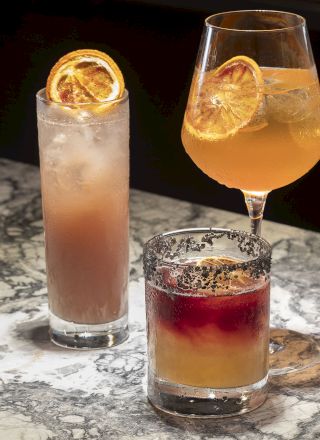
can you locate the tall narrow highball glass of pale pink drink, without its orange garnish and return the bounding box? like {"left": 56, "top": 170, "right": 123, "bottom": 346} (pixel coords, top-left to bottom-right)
{"left": 37, "top": 90, "right": 129, "bottom": 349}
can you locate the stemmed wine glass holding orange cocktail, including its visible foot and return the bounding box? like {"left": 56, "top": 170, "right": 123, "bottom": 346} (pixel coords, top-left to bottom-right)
{"left": 182, "top": 10, "right": 320, "bottom": 374}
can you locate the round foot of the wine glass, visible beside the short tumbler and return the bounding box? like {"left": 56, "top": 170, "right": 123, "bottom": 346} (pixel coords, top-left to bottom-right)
{"left": 269, "top": 328, "right": 320, "bottom": 376}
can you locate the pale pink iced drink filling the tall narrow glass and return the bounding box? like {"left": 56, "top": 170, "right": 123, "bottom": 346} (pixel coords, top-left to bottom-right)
{"left": 38, "top": 103, "right": 128, "bottom": 324}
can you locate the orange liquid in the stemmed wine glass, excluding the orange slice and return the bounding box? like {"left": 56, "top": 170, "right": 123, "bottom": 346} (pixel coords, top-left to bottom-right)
{"left": 182, "top": 67, "right": 320, "bottom": 191}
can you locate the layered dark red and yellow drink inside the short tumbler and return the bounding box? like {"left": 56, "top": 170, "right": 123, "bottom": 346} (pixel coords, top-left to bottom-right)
{"left": 146, "top": 256, "right": 269, "bottom": 388}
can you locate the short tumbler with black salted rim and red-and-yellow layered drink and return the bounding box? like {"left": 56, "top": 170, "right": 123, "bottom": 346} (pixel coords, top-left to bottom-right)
{"left": 143, "top": 228, "right": 271, "bottom": 417}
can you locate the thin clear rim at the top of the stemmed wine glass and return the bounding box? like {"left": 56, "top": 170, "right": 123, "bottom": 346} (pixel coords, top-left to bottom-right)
{"left": 205, "top": 9, "right": 306, "bottom": 33}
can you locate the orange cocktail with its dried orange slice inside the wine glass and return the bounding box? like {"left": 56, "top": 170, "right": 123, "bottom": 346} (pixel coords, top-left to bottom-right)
{"left": 182, "top": 62, "right": 320, "bottom": 192}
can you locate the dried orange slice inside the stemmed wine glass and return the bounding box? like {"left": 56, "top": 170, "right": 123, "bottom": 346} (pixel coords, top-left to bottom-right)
{"left": 185, "top": 55, "right": 263, "bottom": 141}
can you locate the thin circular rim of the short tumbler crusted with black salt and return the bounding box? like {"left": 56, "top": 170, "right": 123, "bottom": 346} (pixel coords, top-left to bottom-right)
{"left": 143, "top": 228, "right": 272, "bottom": 270}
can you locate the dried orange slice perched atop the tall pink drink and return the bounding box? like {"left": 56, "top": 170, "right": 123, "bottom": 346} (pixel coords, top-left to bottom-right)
{"left": 46, "top": 49, "right": 124, "bottom": 104}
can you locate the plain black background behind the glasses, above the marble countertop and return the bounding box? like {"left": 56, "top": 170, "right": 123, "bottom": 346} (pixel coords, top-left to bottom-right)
{"left": 0, "top": 0, "right": 320, "bottom": 230}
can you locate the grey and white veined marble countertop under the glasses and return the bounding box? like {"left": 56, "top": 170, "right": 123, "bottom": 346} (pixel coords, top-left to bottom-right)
{"left": 0, "top": 159, "right": 320, "bottom": 440}
